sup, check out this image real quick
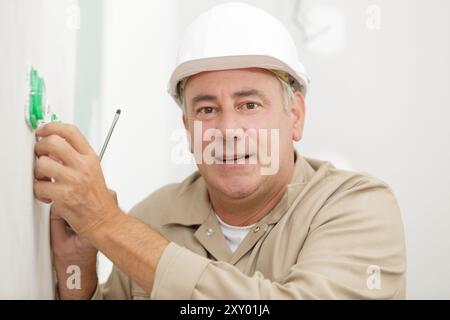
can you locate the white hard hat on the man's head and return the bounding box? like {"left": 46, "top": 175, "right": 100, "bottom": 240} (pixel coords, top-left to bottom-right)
{"left": 168, "top": 2, "right": 309, "bottom": 106}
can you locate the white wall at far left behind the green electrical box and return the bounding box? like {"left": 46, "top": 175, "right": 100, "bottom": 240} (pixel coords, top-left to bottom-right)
{"left": 0, "top": 0, "right": 75, "bottom": 299}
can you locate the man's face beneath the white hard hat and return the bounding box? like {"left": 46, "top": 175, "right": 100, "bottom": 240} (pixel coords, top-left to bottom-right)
{"left": 183, "top": 68, "right": 304, "bottom": 199}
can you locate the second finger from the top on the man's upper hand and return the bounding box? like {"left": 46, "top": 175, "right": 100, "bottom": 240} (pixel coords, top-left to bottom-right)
{"left": 34, "top": 135, "right": 79, "bottom": 166}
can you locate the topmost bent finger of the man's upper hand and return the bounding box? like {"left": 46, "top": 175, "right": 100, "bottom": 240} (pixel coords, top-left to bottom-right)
{"left": 36, "top": 122, "right": 94, "bottom": 155}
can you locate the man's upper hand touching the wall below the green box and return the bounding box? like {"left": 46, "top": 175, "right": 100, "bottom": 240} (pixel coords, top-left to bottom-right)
{"left": 34, "top": 122, "right": 119, "bottom": 236}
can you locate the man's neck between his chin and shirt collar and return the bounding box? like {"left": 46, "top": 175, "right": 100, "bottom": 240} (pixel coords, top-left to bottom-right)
{"left": 209, "top": 155, "right": 294, "bottom": 226}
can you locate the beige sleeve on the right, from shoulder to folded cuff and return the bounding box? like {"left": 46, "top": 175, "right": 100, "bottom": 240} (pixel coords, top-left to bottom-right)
{"left": 151, "top": 181, "right": 406, "bottom": 299}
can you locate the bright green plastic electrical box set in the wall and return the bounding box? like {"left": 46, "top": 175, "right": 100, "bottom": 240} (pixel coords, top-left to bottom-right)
{"left": 25, "top": 67, "right": 59, "bottom": 130}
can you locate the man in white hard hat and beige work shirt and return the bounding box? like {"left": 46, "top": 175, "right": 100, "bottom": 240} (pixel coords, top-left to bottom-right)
{"left": 34, "top": 3, "right": 406, "bottom": 299}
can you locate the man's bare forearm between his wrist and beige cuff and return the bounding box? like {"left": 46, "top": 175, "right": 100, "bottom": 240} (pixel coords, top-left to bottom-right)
{"left": 85, "top": 208, "right": 169, "bottom": 291}
